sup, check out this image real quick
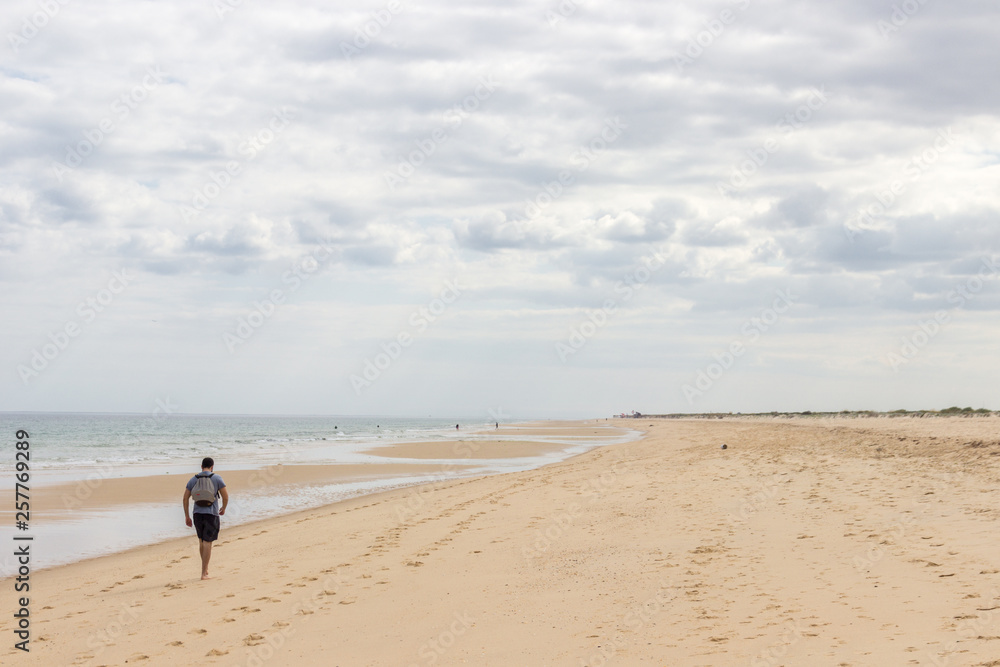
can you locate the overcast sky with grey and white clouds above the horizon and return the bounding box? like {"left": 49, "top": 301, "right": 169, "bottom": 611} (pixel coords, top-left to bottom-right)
{"left": 0, "top": 0, "right": 1000, "bottom": 420}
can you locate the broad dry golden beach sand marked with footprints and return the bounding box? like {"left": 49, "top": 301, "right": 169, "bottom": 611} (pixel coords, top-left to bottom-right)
{"left": 0, "top": 418, "right": 1000, "bottom": 667}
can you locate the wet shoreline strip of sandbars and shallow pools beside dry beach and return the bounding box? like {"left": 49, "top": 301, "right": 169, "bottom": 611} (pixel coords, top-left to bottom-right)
{"left": 0, "top": 421, "right": 636, "bottom": 576}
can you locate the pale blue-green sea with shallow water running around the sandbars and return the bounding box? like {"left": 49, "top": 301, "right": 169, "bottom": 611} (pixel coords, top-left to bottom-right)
{"left": 0, "top": 412, "right": 637, "bottom": 576}
